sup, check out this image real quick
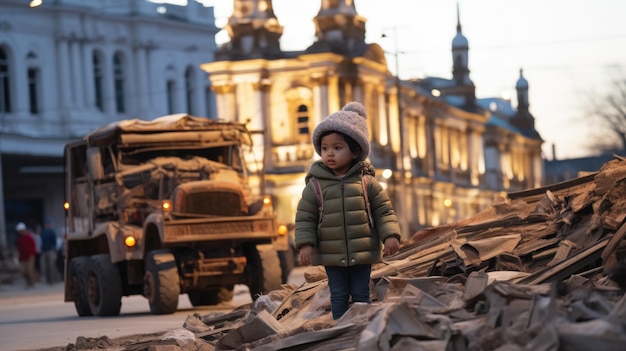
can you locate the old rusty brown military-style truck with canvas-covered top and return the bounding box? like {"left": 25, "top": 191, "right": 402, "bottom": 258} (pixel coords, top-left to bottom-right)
{"left": 64, "top": 114, "right": 288, "bottom": 316}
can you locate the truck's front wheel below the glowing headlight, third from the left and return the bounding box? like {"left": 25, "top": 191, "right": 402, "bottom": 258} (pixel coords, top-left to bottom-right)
{"left": 143, "top": 250, "right": 180, "bottom": 314}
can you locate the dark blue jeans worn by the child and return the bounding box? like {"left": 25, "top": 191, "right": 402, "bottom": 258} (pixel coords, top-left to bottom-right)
{"left": 324, "top": 264, "right": 372, "bottom": 319}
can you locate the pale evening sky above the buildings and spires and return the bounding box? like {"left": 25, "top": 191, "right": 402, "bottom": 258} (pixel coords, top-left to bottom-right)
{"left": 160, "top": 0, "right": 626, "bottom": 159}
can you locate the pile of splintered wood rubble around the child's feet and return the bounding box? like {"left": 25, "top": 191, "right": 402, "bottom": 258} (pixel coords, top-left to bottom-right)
{"left": 127, "top": 156, "right": 626, "bottom": 351}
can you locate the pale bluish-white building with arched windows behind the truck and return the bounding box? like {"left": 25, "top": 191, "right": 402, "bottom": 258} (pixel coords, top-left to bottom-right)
{"left": 0, "top": 0, "right": 219, "bottom": 247}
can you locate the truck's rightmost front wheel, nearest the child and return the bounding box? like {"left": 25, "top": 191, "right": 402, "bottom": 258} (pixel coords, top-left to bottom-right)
{"left": 246, "top": 245, "right": 282, "bottom": 300}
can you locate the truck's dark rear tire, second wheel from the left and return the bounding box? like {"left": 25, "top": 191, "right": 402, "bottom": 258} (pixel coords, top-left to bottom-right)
{"left": 87, "top": 254, "right": 122, "bottom": 316}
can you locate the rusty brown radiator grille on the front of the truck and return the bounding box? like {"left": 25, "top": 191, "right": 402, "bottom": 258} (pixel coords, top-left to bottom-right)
{"left": 182, "top": 192, "right": 242, "bottom": 216}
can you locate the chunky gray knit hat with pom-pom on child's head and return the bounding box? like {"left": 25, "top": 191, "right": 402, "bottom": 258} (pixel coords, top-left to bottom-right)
{"left": 313, "top": 101, "right": 370, "bottom": 161}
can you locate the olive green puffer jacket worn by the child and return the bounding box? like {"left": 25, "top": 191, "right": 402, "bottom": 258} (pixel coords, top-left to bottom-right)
{"left": 295, "top": 161, "right": 400, "bottom": 267}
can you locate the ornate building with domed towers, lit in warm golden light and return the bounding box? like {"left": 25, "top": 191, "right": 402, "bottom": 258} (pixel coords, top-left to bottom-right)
{"left": 202, "top": 0, "right": 542, "bottom": 236}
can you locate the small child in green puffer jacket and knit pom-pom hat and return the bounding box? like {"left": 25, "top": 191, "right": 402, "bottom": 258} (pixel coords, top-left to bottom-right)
{"left": 295, "top": 102, "right": 400, "bottom": 319}
